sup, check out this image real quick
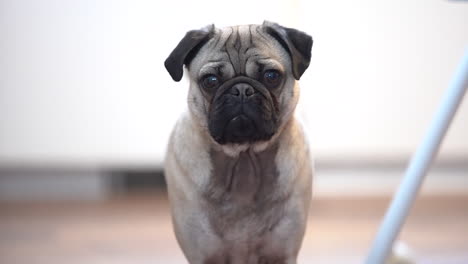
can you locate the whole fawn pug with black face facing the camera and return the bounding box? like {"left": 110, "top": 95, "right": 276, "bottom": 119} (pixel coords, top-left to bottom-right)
{"left": 165, "top": 21, "right": 313, "bottom": 264}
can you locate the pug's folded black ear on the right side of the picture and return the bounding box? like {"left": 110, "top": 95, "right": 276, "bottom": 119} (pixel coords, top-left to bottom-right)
{"left": 263, "top": 21, "right": 313, "bottom": 80}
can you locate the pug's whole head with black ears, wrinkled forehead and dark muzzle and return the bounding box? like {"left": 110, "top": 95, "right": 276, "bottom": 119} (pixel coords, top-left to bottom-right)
{"left": 165, "top": 22, "right": 312, "bottom": 144}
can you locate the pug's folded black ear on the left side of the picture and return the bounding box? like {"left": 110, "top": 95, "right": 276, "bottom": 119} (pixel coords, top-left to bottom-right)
{"left": 164, "top": 25, "right": 214, "bottom": 82}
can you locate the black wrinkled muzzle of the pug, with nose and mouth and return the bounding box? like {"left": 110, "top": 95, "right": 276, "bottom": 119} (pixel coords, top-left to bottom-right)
{"left": 208, "top": 76, "right": 278, "bottom": 144}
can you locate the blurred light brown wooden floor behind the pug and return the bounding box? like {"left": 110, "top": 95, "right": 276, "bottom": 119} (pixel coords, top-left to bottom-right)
{"left": 0, "top": 194, "right": 468, "bottom": 264}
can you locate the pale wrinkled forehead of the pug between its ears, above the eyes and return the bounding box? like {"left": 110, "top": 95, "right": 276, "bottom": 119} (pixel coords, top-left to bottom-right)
{"left": 190, "top": 25, "right": 290, "bottom": 76}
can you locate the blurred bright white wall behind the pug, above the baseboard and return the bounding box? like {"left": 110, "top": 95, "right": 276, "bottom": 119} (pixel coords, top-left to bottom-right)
{"left": 0, "top": 0, "right": 468, "bottom": 166}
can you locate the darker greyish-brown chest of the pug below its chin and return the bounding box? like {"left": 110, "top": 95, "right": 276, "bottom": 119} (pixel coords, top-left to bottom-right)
{"left": 204, "top": 146, "right": 285, "bottom": 239}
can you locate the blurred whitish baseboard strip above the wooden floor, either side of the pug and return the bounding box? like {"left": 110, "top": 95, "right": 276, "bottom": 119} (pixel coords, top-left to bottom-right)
{"left": 0, "top": 165, "right": 468, "bottom": 200}
